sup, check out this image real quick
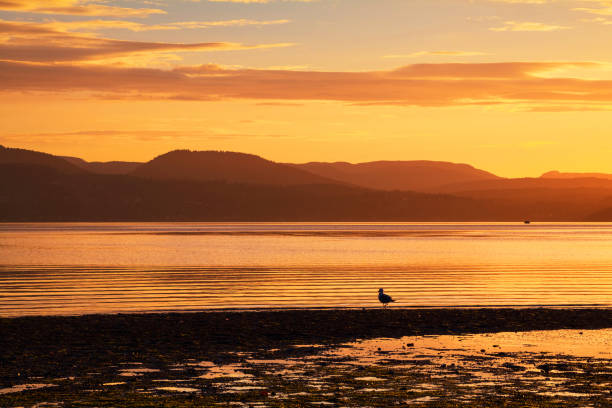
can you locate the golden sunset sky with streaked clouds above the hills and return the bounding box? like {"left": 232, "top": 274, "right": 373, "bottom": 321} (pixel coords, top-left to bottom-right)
{"left": 0, "top": 0, "right": 612, "bottom": 177}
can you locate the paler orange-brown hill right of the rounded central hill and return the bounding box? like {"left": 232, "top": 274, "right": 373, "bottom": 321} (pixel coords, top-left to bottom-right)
{"left": 291, "top": 160, "right": 499, "bottom": 192}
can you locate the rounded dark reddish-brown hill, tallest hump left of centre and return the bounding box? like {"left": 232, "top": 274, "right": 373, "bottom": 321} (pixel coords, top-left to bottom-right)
{"left": 131, "top": 150, "right": 338, "bottom": 186}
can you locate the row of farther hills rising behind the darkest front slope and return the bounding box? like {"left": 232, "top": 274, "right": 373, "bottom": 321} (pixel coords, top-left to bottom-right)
{"left": 0, "top": 148, "right": 499, "bottom": 193}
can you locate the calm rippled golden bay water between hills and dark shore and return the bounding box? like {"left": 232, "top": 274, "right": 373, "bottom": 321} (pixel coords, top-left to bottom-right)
{"left": 0, "top": 223, "right": 612, "bottom": 316}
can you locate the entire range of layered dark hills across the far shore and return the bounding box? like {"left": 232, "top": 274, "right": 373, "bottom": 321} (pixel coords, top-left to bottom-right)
{"left": 0, "top": 146, "right": 612, "bottom": 221}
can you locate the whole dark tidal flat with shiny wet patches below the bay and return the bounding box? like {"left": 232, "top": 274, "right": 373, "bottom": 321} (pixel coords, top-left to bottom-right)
{"left": 0, "top": 308, "right": 612, "bottom": 407}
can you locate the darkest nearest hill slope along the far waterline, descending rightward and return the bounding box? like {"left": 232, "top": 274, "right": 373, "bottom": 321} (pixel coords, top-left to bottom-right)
{"left": 0, "top": 164, "right": 495, "bottom": 221}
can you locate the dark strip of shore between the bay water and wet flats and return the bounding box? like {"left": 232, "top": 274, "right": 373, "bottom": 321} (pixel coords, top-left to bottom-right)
{"left": 0, "top": 308, "right": 612, "bottom": 383}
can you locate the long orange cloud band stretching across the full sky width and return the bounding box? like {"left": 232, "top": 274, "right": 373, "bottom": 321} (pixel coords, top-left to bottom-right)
{"left": 0, "top": 62, "right": 612, "bottom": 108}
